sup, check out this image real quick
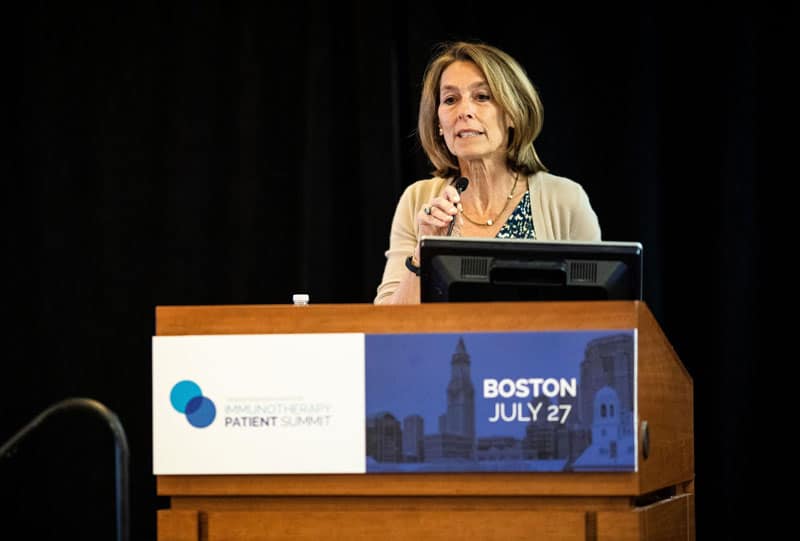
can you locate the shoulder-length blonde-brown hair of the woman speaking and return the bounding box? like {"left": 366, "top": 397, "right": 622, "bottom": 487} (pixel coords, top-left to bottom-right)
{"left": 417, "top": 41, "right": 547, "bottom": 178}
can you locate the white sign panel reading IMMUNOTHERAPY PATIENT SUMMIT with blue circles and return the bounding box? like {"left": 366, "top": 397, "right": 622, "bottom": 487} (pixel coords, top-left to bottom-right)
{"left": 153, "top": 333, "right": 366, "bottom": 475}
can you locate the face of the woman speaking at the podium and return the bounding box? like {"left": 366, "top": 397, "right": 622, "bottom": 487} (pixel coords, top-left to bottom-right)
{"left": 438, "top": 60, "right": 509, "bottom": 160}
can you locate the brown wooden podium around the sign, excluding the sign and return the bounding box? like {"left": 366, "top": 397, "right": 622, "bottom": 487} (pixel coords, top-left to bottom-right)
{"left": 156, "top": 301, "right": 695, "bottom": 541}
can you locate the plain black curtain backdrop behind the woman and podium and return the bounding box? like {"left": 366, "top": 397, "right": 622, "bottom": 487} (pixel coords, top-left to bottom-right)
{"left": 0, "top": 1, "right": 786, "bottom": 539}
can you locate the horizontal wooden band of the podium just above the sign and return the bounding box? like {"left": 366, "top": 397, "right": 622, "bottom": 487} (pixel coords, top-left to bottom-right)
{"left": 156, "top": 301, "right": 649, "bottom": 335}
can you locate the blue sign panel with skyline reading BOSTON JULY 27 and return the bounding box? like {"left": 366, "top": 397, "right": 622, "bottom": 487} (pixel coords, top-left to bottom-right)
{"left": 366, "top": 329, "right": 638, "bottom": 473}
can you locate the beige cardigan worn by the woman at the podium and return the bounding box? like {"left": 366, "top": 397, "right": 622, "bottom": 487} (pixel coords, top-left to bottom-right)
{"left": 374, "top": 171, "right": 600, "bottom": 303}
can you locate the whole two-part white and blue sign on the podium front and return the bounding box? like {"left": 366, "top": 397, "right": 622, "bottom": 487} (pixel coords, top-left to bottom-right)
{"left": 153, "top": 329, "right": 638, "bottom": 475}
